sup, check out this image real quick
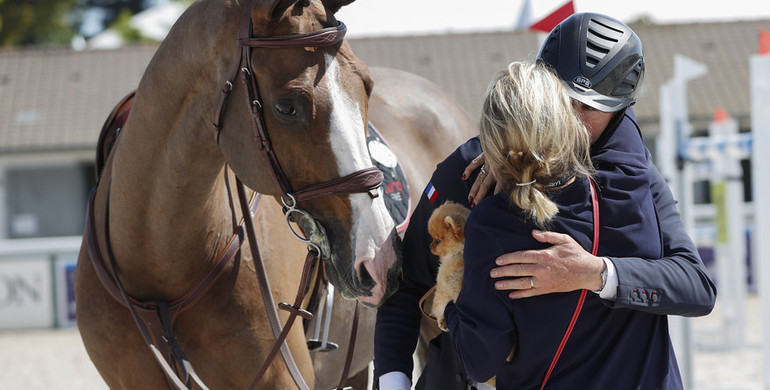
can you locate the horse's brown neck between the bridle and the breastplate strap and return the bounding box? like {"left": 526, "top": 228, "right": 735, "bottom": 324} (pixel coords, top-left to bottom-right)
{"left": 103, "top": 1, "right": 238, "bottom": 298}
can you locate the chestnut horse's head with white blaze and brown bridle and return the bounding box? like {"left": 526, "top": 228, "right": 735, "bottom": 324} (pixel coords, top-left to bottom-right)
{"left": 218, "top": 0, "right": 400, "bottom": 305}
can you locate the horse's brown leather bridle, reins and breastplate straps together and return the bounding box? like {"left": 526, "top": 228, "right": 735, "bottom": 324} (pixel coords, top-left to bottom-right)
{"left": 85, "top": 0, "right": 383, "bottom": 390}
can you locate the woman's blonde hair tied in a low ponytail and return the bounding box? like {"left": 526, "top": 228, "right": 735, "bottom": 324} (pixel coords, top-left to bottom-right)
{"left": 479, "top": 62, "right": 593, "bottom": 227}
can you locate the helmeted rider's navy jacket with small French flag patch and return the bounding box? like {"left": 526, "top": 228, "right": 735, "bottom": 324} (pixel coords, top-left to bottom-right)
{"left": 375, "top": 110, "right": 716, "bottom": 388}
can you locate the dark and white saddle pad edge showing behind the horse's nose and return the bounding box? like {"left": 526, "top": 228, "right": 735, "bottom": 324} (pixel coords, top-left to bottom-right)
{"left": 366, "top": 122, "right": 412, "bottom": 233}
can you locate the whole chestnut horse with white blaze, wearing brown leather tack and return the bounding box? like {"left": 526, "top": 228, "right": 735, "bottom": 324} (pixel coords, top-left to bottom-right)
{"left": 75, "top": 0, "right": 475, "bottom": 389}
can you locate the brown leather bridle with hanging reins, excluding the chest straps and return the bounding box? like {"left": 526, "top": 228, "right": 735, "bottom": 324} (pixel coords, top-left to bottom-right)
{"left": 214, "top": 0, "right": 383, "bottom": 389}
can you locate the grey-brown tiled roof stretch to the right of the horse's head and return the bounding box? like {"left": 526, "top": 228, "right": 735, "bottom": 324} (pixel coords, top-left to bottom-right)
{"left": 351, "top": 20, "right": 770, "bottom": 132}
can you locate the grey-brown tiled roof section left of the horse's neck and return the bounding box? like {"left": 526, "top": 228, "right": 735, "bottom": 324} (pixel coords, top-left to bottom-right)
{"left": 0, "top": 45, "right": 157, "bottom": 153}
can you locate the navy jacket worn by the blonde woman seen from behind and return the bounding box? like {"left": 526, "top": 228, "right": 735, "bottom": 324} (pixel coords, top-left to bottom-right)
{"left": 445, "top": 106, "right": 682, "bottom": 390}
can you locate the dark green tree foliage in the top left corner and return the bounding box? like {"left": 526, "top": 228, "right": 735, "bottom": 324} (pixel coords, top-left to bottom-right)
{"left": 0, "top": 0, "right": 78, "bottom": 46}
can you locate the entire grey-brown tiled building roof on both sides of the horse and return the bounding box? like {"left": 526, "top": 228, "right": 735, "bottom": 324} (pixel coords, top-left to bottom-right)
{"left": 0, "top": 20, "right": 770, "bottom": 153}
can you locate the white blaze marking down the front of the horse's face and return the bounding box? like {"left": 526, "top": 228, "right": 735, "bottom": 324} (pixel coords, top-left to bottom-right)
{"left": 325, "top": 54, "right": 394, "bottom": 266}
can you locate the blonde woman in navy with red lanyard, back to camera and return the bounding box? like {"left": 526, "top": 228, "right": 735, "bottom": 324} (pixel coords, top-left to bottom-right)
{"left": 444, "top": 62, "right": 682, "bottom": 390}
